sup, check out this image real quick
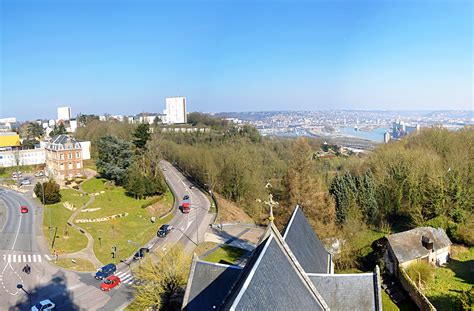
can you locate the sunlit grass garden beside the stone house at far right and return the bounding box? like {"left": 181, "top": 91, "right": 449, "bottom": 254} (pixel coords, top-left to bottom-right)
{"left": 424, "top": 245, "right": 474, "bottom": 310}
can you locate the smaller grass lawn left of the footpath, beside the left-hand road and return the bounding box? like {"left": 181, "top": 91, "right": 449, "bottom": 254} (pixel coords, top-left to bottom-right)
{"left": 43, "top": 189, "right": 89, "bottom": 253}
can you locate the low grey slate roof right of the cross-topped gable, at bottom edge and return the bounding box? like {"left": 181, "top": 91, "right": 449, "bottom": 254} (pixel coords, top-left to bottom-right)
{"left": 308, "top": 272, "right": 382, "bottom": 311}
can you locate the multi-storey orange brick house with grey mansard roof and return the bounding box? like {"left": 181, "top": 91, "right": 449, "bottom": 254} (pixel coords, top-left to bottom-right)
{"left": 45, "top": 135, "right": 83, "bottom": 179}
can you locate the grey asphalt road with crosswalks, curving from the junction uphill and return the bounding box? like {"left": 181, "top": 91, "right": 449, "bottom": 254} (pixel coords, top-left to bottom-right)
{"left": 0, "top": 161, "right": 212, "bottom": 310}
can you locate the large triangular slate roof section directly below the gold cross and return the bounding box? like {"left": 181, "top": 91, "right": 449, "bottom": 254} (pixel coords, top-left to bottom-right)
{"left": 221, "top": 224, "right": 328, "bottom": 311}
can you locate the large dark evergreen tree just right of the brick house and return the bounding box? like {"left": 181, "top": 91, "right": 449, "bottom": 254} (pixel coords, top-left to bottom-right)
{"left": 96, "top": 135, "right": 132, "bottom": 185}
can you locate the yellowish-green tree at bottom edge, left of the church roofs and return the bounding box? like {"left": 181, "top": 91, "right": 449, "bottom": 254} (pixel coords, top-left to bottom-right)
{"left": 134, "top": 246, "right": 191, "bottom": 310}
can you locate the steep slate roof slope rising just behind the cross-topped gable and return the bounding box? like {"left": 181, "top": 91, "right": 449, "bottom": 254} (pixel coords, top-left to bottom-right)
{"left": 283, "top": 206, "right": 332, "bottom": 273}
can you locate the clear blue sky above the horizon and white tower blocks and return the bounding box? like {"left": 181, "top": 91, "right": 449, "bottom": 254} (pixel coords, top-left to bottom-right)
{"left": 0, "top": 0, "right": 473, "bottom": 119}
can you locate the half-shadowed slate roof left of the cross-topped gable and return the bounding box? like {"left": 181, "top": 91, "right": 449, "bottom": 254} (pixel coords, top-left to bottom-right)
{"left": 183, "top": 258, "right": 242, "bottom": 311}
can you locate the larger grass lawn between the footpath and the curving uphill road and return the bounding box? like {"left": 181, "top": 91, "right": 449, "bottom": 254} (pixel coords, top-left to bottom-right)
{"left": 76, "top": 178, "right": 173, "bottom": 264}
